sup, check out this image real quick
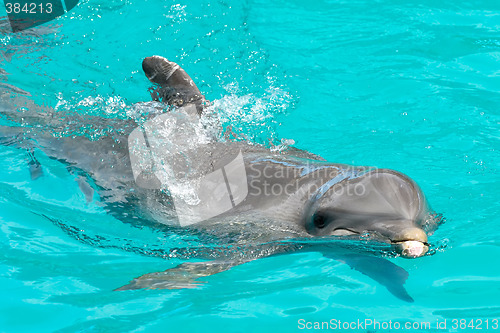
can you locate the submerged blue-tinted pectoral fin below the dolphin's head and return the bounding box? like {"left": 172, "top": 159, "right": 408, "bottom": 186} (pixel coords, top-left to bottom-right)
{"left": 325, "top": 254, "right": 414, "bottom": 303}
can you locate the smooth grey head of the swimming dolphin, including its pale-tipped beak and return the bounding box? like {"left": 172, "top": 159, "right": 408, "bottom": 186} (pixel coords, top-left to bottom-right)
{"left": 305, "top": 169, "right": 429, "bottom": 258}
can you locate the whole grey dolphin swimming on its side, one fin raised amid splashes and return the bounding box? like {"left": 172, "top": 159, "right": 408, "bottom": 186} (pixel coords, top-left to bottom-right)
{"left": 0, "top": 56, "right": 438, "bottom": 301}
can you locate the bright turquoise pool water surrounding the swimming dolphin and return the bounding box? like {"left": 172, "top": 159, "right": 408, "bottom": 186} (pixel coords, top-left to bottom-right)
{"left": 0, "top": 0, "right": 500, "bottom": 332}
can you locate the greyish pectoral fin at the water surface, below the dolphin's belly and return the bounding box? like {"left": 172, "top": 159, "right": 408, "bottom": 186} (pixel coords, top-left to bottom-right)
{"left": 115, "top": 260, "right": 244, "bottom": 291}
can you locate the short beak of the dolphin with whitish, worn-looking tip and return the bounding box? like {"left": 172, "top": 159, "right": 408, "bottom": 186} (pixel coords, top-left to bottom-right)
{"left": 391, "top": 228, "right": 429, "bottom": 258}
